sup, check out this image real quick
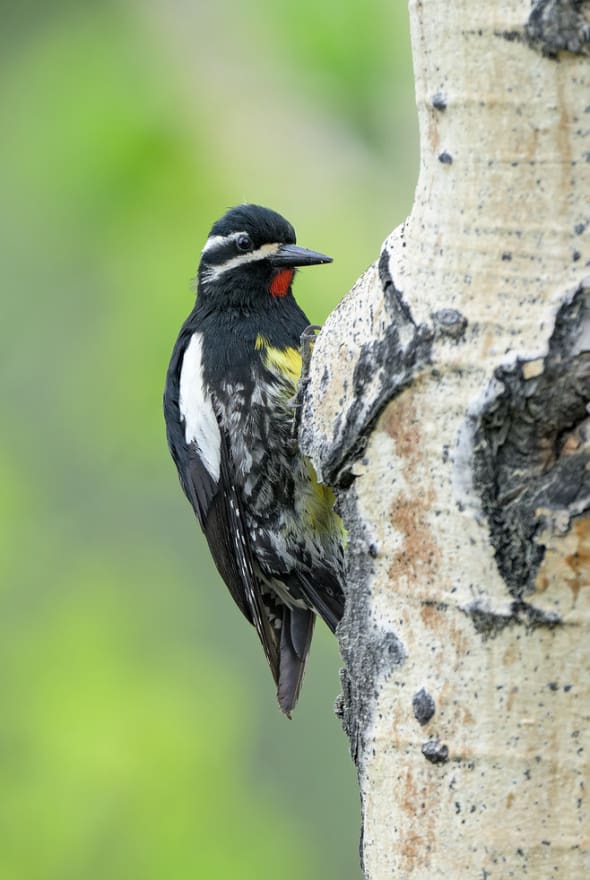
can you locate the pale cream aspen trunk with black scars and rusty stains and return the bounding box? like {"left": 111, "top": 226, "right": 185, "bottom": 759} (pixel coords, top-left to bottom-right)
{"left": 302, "top": 0, "right": 590, "bottom": 880}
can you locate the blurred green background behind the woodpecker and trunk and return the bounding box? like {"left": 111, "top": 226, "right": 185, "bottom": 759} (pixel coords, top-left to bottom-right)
{"left": 0, "top": 0, "right": 417, "bottom": 880}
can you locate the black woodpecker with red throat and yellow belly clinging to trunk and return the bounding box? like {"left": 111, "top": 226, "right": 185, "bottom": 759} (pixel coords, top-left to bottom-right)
{"left": 164, "top": 204, "right": 344, "bottom": 717}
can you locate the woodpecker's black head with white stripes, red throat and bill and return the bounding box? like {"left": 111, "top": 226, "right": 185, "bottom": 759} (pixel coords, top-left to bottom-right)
{"left": 198, "top": 205, "right": 332, "bottom": 309}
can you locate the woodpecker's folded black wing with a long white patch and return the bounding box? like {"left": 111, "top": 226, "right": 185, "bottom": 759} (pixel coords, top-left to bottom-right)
{"left": 164, "top": 333, "right": 280, "bottom": 684}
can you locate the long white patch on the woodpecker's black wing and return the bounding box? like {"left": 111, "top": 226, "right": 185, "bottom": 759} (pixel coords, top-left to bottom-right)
{"left": 178, "top": 333, "right": 221, "bottom": 481}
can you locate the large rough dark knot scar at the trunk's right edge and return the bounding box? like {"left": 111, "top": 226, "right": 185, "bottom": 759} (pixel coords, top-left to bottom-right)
{"left": 473, "top": 284, "right": 590, "bottom": 600}
